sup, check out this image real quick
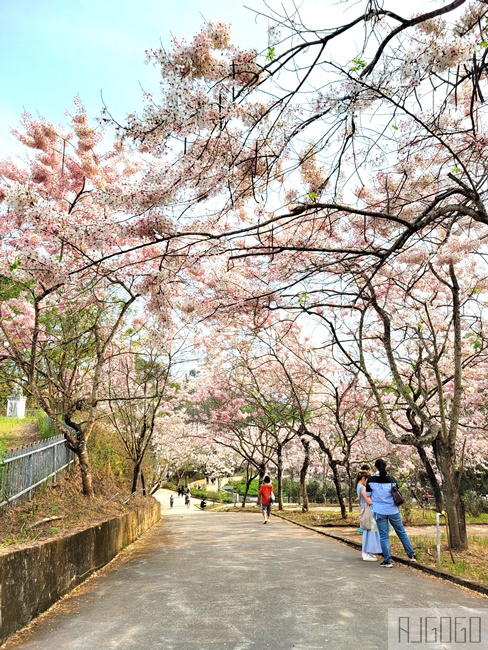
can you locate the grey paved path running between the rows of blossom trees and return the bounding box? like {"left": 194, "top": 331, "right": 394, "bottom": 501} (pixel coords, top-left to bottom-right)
{"left": 4, "top": 494, "right": 488, "bottom": 650}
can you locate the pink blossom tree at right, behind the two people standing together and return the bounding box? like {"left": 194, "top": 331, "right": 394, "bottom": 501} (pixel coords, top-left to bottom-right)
{"left": 310, "top": 248, "right": 487, "bottom": 548}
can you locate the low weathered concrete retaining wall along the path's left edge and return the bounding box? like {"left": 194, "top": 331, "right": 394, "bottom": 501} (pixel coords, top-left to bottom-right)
{"left": 0, "top": 499, "right": 161, "bottom": 644}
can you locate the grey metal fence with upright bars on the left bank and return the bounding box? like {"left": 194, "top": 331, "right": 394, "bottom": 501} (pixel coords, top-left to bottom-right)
{"left": 0, "top": 435, "right": 74, "bottom": 507}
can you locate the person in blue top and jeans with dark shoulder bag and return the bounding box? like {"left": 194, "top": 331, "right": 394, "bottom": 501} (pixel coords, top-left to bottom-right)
{"left": 366, "top": 458, "right": 417, "bottom": 569}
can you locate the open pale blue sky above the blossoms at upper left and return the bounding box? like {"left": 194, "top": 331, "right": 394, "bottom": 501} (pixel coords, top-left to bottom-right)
{"left": 0, "top": 0, "right": 267, "bottom": 158}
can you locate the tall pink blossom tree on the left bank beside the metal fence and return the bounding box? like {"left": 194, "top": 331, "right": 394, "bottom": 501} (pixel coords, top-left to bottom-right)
{"left": 0, "top": 104, "right": 143, "bottom": 495}
